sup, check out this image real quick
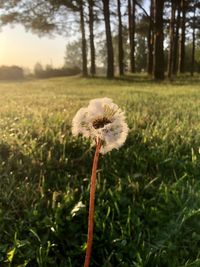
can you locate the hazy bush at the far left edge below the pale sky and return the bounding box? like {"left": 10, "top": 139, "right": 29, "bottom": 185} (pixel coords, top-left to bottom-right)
{"left": 0, "top": 66, "right": 24, "bottom": 80}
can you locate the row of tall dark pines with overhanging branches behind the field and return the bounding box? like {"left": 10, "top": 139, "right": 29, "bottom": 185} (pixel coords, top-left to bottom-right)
{"left": 0, "top": 0, "right": 200, "bottom": 80}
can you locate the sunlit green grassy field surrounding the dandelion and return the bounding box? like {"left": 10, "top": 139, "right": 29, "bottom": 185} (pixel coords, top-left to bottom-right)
{"left": 0, "top": 77, "right": 200, "bottom": 267}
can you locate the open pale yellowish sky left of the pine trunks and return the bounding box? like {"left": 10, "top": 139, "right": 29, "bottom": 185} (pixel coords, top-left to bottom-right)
{"left": 0, "top": 25, "right": 67, "bottom": 69}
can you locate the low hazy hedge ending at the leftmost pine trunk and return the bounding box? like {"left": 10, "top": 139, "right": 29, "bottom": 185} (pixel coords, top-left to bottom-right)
{"left": 35, "top": 67, "right": 81, "bottom": 79}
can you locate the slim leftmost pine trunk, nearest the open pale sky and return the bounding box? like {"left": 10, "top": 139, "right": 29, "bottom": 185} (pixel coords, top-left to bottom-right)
{"left": 80, "top": 0, "right": 88, "bottom": 77}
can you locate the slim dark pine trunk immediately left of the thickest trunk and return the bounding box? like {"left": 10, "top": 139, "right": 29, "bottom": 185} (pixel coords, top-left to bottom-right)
{"left": 147, "top": 0, "right": 154, "bottom": 75}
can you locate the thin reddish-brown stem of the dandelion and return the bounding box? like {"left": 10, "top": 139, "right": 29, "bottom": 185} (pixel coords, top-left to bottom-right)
{"left": 84, "top": 139, "right": 101, "bottom": 267}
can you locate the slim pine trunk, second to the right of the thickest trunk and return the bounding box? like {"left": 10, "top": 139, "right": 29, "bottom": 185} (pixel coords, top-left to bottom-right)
{"left": 172, "top": 1, "right": 181, "bottom": 75}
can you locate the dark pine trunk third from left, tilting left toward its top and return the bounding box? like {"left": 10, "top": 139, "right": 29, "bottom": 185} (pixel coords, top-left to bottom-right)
{"left": 103, "top": 0, "right": 114, "bottom": 79}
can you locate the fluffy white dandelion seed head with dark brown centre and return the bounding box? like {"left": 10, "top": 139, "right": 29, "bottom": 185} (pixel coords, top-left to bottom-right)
{"left": 72, "top": 97, "right": 128, "bottom": 154}
